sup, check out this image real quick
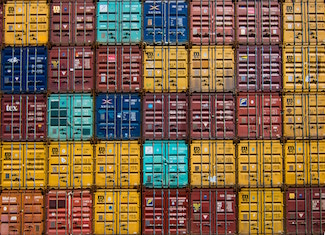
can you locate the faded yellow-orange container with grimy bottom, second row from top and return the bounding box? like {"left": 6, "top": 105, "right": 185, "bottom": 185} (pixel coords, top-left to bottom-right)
{"left": 190, "top": 46, "right": 235, "bottom": 92}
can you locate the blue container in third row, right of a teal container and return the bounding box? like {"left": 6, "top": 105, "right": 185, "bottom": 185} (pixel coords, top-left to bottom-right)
{"left": 96, "top": 94, "right": 141, "bottom": 140}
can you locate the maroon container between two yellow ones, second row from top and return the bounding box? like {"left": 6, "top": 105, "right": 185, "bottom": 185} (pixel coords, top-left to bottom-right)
{"left": 237, "top": 46, "right": 282, "bottom": 92}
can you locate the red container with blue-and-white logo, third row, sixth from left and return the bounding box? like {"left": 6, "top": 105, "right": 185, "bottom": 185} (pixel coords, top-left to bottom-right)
{"left": 237, "top": 93, "right": 282, "bottom": 139}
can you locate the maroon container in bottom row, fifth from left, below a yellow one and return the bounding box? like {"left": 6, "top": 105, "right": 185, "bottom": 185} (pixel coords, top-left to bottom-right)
{"left": 190, "top": 189, "right": 237, "bottom": 235}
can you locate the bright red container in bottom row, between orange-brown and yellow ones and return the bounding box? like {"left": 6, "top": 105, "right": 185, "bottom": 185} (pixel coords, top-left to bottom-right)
{"left": 46, "top": 190, "right": 92, "bottom": 235}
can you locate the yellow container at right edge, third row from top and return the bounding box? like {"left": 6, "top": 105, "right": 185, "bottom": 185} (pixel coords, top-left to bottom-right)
{"left": 283, "top": 93, "right": 325, "bottom": 139}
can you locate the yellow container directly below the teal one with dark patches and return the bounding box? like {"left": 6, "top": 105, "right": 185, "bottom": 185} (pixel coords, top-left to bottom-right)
{"left": 48, "top": 141, "right": 94, "bottom": 189}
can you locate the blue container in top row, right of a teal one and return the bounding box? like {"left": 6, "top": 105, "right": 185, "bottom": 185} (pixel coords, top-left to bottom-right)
{"left": 143, "top": 0, "right": 188, "bottom": 44}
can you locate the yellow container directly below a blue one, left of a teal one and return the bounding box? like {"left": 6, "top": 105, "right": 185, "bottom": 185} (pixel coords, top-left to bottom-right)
{"left": 95, "top": 141, "right": 141, "bottom": 189}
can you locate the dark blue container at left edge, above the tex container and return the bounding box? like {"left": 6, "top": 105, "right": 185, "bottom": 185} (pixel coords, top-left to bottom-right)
{"left": 1, "top": 47, "right": 47, "bottom": 93}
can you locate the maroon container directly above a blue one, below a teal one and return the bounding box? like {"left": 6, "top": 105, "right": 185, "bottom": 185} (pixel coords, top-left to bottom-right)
{"left": 96, "top": 46, "right": 142, "bottom": 92}
